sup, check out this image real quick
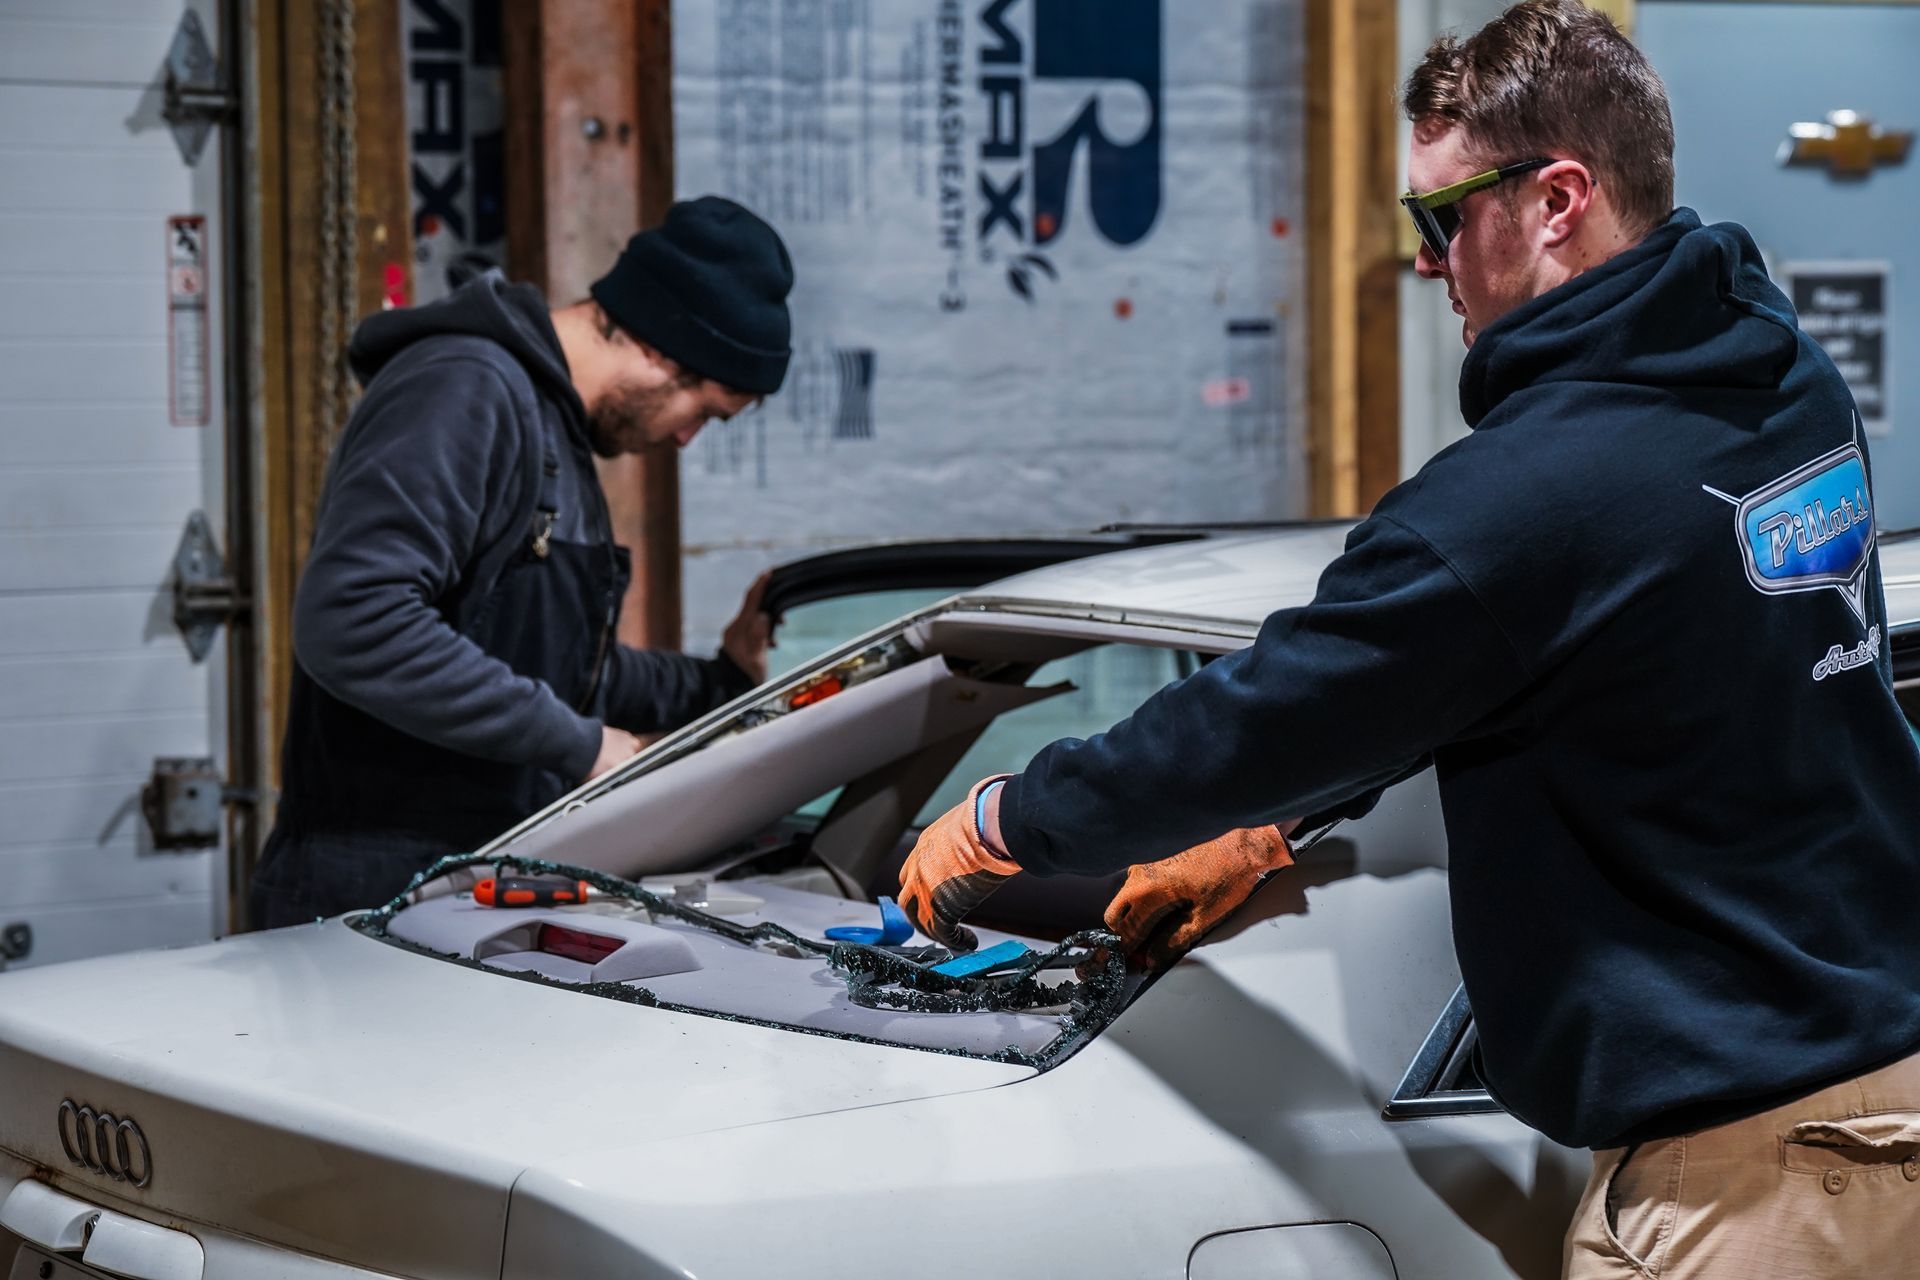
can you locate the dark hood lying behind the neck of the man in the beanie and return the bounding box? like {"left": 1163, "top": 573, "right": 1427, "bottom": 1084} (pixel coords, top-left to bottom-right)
{"left": 348, "top": 271, "right": 586, "bottom": 420}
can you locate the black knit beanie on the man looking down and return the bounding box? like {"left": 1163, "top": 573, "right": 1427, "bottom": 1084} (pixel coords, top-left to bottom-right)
{"left": 591, "top": 196, "right": 793, "bottom": 395}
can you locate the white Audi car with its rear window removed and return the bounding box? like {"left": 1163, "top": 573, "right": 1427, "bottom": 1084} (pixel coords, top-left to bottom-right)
{"left": 0, "top": 526, "right": 1920, "bottom": 1280}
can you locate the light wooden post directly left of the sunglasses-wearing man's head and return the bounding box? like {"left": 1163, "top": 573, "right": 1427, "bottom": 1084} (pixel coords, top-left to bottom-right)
{"left": 1308, "top": 0, "right": 1400, "bottom": 516}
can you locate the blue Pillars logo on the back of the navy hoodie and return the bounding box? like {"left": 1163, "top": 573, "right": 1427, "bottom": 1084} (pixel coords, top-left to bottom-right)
{"left": 1701, "top": 445, "right": 1874, "bottom": 622}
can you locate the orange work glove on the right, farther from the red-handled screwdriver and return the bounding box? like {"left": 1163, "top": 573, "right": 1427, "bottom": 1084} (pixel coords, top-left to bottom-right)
{"left": 1106, "top": 825, "right": 1294, "bottom": 967}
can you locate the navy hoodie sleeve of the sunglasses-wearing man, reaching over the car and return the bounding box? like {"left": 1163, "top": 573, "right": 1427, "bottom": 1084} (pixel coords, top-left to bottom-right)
{"left": 1000, "top": 514, "right": 1528, "bottom": 875}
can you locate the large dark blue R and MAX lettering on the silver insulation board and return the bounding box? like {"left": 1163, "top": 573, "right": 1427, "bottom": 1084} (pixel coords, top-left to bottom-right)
{"left": 939, "top": 0, "right": 1162, "bottom": 311}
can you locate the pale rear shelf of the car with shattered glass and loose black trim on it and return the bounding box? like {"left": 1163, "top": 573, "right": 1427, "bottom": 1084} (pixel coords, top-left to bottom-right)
{"left": 349, "top": 854, "right": 1137, "bottom": 1071}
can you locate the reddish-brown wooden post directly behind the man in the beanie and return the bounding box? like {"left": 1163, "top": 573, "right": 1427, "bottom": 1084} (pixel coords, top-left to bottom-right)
{"left": 503, "top": 0, "right": 680, "bottom": 649}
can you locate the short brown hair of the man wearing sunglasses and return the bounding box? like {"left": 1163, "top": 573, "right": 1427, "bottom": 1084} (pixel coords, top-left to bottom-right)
{"left": 1400, "top": 0, "right": 1674, "bottom": 234}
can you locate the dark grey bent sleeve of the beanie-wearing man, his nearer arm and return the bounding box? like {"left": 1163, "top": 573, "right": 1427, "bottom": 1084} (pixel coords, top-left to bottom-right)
{"left": 294, "top": 355, "right": 601, "bottom": 777}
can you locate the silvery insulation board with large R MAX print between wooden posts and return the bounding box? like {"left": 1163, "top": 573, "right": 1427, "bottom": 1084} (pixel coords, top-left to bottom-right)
{"left": 674, "top": 0, "right": 1308, "bottom": 645}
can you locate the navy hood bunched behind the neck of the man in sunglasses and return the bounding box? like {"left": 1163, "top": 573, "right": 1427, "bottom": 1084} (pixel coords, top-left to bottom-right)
{"left": 1459, "top": 209, "right": 1799, "bottom": 426}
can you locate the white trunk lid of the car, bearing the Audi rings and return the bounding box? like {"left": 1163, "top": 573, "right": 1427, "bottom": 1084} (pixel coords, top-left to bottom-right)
{"left": 0, "top": 921, "right": 1031, "bottom": 1276}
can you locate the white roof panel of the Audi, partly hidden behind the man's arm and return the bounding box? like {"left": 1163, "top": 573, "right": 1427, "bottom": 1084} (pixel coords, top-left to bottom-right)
{"left": 962, "top": 524, "right": 1920, "bottom": 629}
